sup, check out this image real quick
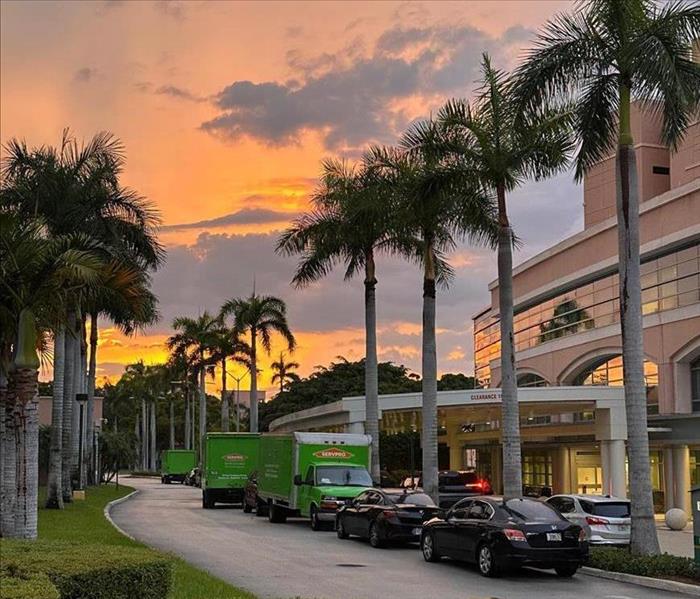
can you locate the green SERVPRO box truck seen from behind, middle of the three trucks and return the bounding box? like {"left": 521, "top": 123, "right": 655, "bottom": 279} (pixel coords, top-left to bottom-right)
{"left": 202, "top": 433, "right": 260, "bottom": 509}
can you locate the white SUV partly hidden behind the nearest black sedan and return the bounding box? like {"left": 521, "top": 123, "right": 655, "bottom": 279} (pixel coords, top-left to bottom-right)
{"left": 547, "top": 495, "right": 631, "bottom": 545}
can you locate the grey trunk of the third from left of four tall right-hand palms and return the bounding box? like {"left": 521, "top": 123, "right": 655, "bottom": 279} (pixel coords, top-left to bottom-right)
{"left": 496, "top": 185, "right": 523, "bottom": 497}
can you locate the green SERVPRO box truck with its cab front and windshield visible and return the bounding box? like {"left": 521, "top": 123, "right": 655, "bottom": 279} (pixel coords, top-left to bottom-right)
{"left": 258, "top": 433, "right": 373, "bottom": 530}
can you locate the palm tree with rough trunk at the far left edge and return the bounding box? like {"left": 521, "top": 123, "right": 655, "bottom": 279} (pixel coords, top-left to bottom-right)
{"left": 0, "top": 211, "right": 102, "bottom": 538}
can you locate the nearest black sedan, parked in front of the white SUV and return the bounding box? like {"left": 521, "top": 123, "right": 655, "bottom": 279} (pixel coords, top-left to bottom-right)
{"left": 421, "top": 497, "right": 588, "bottom": 577}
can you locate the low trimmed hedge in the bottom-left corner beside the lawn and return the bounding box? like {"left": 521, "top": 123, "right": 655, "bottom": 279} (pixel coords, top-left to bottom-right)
{"left": 2, "top": 541, "right": 172, "bottom": 599}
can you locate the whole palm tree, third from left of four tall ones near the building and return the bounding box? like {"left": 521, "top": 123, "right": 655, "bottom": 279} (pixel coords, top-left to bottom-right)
{"left": 438, "top": 54, "right": 572, "bottom": 497}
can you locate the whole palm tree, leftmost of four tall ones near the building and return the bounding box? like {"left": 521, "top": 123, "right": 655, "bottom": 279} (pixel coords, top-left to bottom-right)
{"left": 273, "top": 160, "right": 397, "bottom": 481}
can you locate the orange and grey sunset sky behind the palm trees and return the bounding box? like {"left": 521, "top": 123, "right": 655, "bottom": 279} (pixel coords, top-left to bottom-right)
{"left": 0, "top": 0, "right": 583, "bottom": 391}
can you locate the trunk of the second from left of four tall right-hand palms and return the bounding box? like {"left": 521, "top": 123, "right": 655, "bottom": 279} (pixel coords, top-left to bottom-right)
{"left": 421, "top": 245, "right": 439, "bottom": 505}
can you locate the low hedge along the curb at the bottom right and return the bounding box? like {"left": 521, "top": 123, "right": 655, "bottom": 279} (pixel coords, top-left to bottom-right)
{"left": 588, "top": 547, "right": 700, "bottom": 580}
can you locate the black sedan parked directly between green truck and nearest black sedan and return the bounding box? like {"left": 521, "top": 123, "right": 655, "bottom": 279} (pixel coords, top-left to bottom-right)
{"left": 335, "top": 489, "right": 439, "bottom": 547}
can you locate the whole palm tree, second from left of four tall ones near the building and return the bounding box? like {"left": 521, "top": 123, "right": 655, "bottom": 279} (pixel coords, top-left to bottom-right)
{"left": 367, "top": 120, "right": 497, "bottom": 501}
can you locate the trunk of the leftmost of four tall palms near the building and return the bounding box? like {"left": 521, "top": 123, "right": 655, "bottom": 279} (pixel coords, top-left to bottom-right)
{"left": 365, "top": 251, "right": 381, "bottom": 485}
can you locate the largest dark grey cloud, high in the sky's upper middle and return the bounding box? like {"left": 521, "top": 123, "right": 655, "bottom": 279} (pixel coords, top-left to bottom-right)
{"left": 201, "top": 25, "right": 526, "bottom": 150}
